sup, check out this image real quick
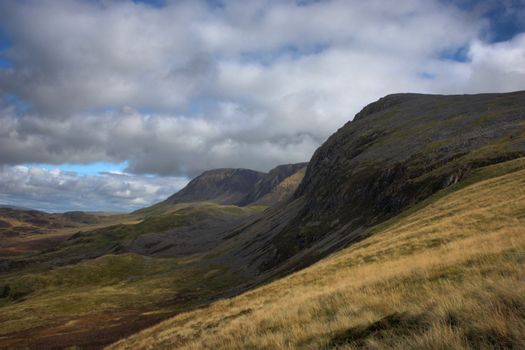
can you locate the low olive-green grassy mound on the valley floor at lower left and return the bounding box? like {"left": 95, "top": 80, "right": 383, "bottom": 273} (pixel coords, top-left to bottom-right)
{"left": 0, "top": 253, "right": 242, "bottom": 343}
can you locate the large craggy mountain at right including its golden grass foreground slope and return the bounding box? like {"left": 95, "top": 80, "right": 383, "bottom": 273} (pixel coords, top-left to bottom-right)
{"left": 110, "top": 92, "right": 525, "bottom": 349}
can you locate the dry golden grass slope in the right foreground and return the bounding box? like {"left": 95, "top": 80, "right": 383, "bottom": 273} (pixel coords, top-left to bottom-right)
{"left": 111, "top": 163, "right": 525, "bottom": 349}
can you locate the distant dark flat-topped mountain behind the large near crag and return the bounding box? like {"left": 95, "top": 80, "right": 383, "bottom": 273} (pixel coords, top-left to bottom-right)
{"left": 166, "top": 163, "right": 307, "bottom": 206}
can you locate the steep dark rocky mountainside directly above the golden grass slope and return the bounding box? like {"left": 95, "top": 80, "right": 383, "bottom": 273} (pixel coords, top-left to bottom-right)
{"left": 244, "top": 91, "right": 525, "bottom": 272}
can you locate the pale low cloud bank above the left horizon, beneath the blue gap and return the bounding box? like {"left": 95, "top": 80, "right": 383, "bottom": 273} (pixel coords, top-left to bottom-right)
{"left": 0, "top": 165, "right": 187, "bottom": 212}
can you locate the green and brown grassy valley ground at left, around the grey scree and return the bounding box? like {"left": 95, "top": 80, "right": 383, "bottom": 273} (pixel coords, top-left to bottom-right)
{"left": 0, "top": 203, "right": 263, "bottom": 348}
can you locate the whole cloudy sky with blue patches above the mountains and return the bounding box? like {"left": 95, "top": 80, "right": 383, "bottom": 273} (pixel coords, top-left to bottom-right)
{"left": 0, "top": 0, "right": 525, "bottom": 212}
